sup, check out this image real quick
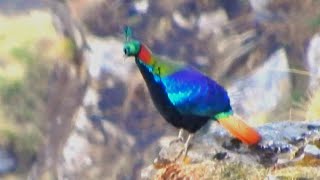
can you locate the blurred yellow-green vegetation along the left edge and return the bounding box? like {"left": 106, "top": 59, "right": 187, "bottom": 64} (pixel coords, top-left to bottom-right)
{"left": 0, "top": 11, "right": 65, "bottom": 171}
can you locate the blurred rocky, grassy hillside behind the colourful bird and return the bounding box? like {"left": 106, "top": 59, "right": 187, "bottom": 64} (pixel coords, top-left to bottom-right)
{"left": 0, "top": 0, "right": 320, "bottom": 179}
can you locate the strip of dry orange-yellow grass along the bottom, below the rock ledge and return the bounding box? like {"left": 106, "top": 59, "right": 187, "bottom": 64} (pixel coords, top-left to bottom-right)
{"left": 154, "top": 161, "right": 320, "bottom": 180}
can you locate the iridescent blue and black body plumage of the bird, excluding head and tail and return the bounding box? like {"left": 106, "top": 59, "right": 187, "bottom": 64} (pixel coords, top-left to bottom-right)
{"left": 136, "top": 58, "right": 231, "bottom": 133}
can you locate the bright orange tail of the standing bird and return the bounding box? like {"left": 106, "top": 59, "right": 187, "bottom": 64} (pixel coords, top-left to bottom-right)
{"left": 218, "top": 115, "right": 261, "bottom": 145}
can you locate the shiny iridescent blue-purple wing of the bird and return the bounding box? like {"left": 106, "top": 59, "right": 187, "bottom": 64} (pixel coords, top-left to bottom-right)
{"left": 161, "top": 67, "right": 231, "bottom": 117}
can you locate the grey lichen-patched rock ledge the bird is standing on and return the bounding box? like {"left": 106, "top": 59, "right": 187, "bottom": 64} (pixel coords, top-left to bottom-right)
{"left": 142, "top": 121, "right": 320, "bottom": 179}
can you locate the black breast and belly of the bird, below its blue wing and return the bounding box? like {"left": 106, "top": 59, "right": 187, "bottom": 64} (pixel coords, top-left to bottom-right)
{"left": 136, "top": 60, "right": 210, "bottom": 133}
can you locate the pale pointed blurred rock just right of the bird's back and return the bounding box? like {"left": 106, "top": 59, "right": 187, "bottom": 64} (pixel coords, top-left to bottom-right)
{"left": 228, "top": 49, "right": 291, "bottom": 123}
